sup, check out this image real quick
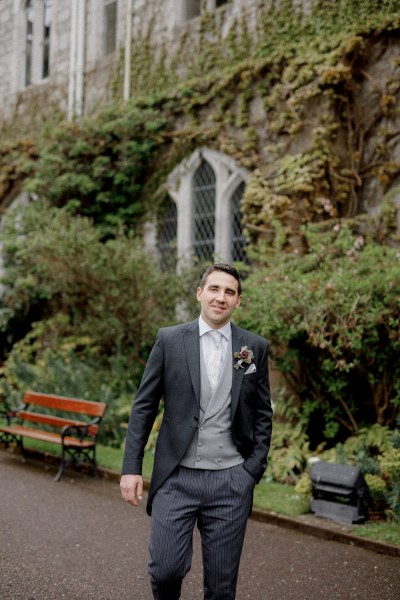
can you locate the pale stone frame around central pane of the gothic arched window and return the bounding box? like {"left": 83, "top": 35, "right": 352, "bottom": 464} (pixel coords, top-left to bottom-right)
{"left": 167, "top": 147, "right": 250, "bottom": 266}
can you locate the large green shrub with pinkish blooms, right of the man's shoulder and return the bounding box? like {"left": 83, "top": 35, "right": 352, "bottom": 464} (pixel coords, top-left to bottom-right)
{"left": 240, "top": 222, "right": 400, "bottom": 440}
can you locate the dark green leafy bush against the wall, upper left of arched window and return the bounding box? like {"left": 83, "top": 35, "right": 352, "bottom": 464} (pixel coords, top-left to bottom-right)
{"left": 21, "top": 104, "right": 166, "bottom": 235}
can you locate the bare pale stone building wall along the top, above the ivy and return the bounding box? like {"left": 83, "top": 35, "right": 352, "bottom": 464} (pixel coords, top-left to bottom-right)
{"left": 0, "top": 0, "right": 284, "bottom": 120}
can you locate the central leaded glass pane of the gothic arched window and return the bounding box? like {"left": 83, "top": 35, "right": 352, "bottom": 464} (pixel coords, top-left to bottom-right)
{"left": 192, "top": 160, "right": 215, "bottom": 261}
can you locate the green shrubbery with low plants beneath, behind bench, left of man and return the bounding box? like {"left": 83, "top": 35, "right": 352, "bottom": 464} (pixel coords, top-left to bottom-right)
{"left": 0, "top": 202, "right": 185, "bottom": 444}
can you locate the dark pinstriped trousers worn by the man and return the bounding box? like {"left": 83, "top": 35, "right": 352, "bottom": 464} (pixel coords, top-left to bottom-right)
{"left": 149, "top": 464, "right": 255, "bottom": 600}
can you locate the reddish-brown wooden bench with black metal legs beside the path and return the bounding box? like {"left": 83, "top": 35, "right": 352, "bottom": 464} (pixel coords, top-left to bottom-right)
{"left": 0, "top": 392, "right": 107, "bottom": 481}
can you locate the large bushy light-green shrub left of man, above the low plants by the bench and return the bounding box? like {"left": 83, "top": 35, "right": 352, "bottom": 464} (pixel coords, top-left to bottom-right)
{"left": 0, "top": 203, "right": 180, "bottom": 366}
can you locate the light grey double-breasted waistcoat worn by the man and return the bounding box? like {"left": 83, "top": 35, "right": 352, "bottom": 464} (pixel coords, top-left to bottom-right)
{"left": 180, "top": 344, "right": 244, "bottom": 470}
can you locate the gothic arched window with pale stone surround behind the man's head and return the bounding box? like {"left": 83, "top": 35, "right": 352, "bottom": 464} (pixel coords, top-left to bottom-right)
{"left": 168, "top": 147, "right": 249, "bottom": 267}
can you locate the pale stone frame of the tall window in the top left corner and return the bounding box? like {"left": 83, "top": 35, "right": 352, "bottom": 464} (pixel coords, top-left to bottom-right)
{"left": 19, "top": 0, "right": 55, "bottom": 89}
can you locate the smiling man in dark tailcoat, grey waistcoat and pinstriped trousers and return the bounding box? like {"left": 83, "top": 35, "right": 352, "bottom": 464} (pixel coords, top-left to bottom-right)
{"left": 121, "top": 264, "right": 272, "bottom": 600}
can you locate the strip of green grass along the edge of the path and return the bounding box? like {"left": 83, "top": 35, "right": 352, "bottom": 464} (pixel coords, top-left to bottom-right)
{"left": 3, "top": 439, "right": 400, "bottom": 546}
